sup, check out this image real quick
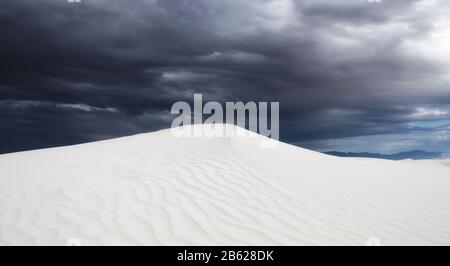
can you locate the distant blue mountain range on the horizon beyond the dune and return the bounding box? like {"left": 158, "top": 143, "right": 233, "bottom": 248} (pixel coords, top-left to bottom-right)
{"left": 325, "top": 150, "right": 444, "bottom": 160}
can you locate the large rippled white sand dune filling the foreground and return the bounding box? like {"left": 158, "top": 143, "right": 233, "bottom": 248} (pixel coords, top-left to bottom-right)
{"left": 0, "top": 126, "right": 450, "bottom": 245}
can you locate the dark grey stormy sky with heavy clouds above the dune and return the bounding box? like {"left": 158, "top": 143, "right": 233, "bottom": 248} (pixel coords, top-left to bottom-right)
{"left": 0, "top": 0, "right": 450, "bottom": 153}
